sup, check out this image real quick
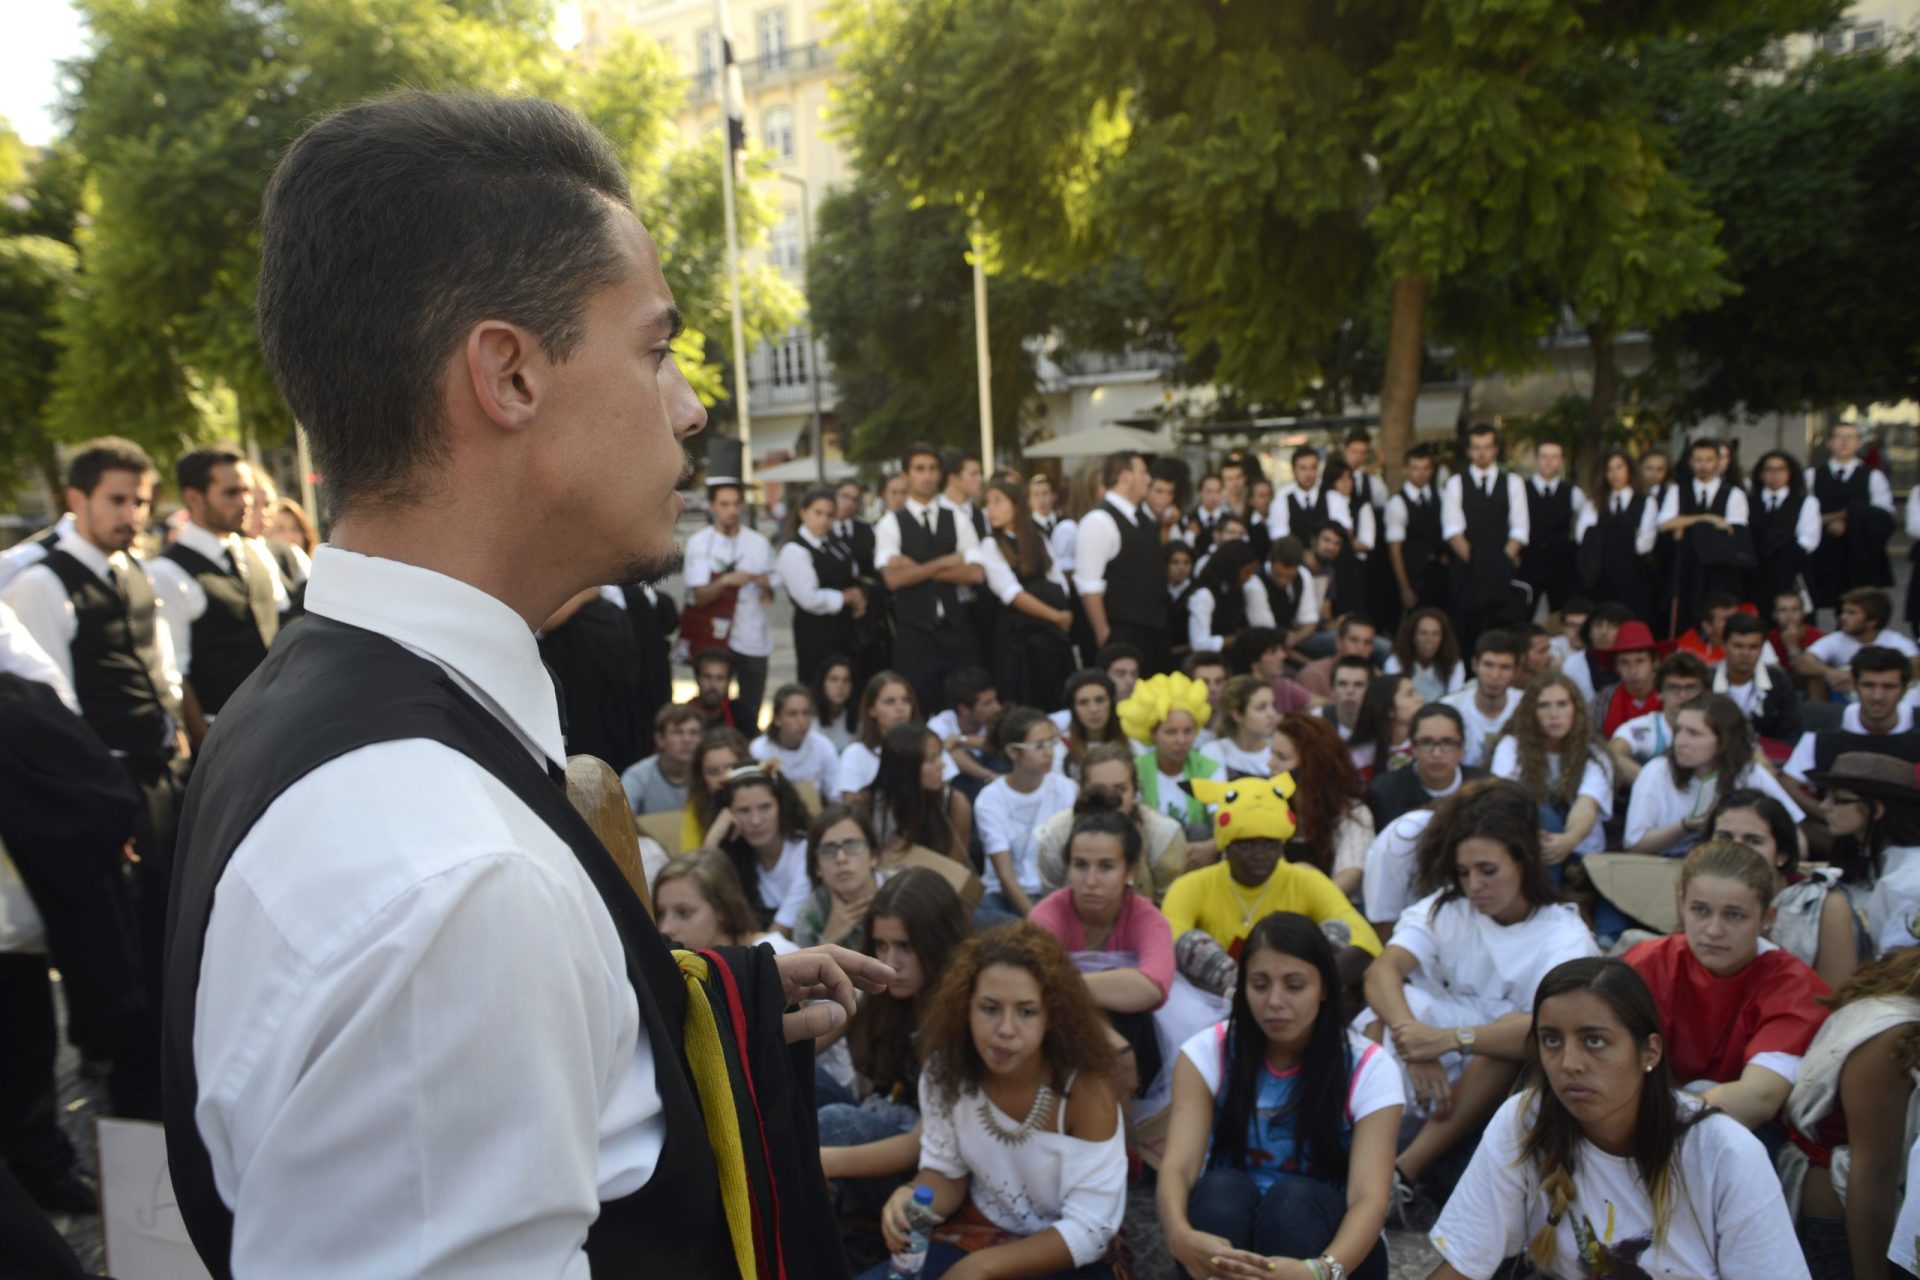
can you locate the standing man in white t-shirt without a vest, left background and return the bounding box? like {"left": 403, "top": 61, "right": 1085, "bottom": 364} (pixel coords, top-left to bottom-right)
{"left": 684, "top": 480, "right": 778, "bottom": 722}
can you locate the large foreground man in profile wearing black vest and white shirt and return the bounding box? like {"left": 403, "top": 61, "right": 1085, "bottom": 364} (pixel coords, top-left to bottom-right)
{"left": 165, "top": 92, "right": 891, "bottom": 1278}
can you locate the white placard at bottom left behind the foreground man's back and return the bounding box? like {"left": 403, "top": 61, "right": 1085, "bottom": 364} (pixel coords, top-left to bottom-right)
{"left": 94, "top": 1119, "right": 211, "bottom": 1280}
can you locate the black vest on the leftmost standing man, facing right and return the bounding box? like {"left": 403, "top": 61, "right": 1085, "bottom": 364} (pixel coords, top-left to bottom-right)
{"left": 42, "top": 551, "right": 180, "bottom": 756}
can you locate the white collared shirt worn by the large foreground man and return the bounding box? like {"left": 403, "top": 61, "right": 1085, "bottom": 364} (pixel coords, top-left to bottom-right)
{"left": 194, "top": 547, "right": 664, "bottom": 1280}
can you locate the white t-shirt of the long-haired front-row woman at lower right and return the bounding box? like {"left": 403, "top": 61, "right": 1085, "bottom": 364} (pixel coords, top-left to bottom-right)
{"left": 1430, "top": 1090, "right": 1804, "bottom": 1280}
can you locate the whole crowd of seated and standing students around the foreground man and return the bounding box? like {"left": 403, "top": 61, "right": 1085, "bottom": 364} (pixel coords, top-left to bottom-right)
{"left": 0, "top": 424, "right": 1920, "bottom": 1280}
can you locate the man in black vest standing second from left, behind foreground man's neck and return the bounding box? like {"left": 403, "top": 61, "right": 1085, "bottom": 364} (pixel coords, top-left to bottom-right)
{"left": 148, "top": 447, "right": 286, "bottom": 747}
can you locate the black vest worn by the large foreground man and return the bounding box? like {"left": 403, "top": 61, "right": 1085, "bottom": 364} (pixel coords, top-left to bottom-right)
{"left": 161, "top": 618, "right": 733, "bottom": 1280}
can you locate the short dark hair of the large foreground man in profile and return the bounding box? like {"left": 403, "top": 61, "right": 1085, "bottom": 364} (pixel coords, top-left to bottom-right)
{"left": 259, "top": 92, "right": 632, "bottom": 516}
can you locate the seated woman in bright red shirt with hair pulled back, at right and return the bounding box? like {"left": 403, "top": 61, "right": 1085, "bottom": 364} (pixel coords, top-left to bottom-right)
{"left": 1626, "top": 841, "right": 1832, "bottom": 1128}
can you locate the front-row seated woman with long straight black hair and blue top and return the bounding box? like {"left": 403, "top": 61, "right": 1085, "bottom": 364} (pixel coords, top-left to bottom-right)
{"left": 1156, "top": 912, "right": 1404, "bottom": 1280}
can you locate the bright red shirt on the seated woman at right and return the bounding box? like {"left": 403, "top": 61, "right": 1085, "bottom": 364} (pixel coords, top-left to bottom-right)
{"left": 1626, "top": 933, "right": 1832, "bottom": 1084}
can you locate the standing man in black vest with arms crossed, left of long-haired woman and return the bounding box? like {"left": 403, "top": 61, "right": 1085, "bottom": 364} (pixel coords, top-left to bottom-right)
{"left": 874, "top": 445, "right": 987, "bottom": 716}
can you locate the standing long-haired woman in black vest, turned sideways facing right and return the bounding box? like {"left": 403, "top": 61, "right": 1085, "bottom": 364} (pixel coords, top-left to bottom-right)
{"left": 973, "top": 480, "right": 1073, "bottom": 712}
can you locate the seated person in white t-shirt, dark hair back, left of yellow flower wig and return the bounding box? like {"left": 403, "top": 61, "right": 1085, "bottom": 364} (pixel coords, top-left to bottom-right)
{"left": 973, "top": 706, "right": 1079, "bottom": 929}
